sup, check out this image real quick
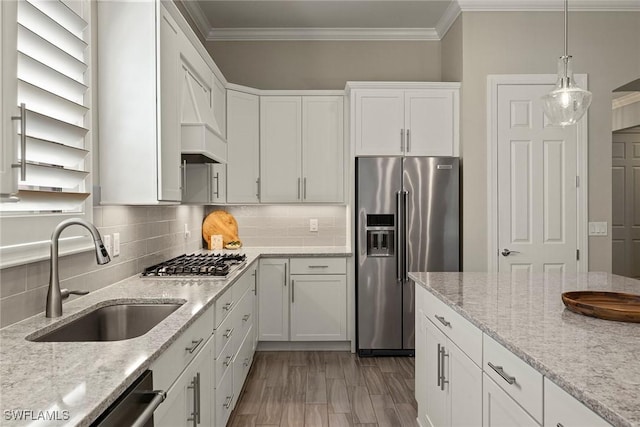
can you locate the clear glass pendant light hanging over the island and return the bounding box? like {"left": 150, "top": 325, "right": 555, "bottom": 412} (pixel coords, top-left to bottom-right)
{"left": 542, "top": 0, "right": 591, "bottom": 126}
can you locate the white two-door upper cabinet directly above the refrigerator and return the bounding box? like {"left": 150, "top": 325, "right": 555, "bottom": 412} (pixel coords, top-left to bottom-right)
{"left": 347, "top": 83, "right": 460, "bottom": 156}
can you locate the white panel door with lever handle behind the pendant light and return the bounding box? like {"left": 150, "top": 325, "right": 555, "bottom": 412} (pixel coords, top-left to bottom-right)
{"left": 498, "top": 85, "right": 577, "bottom": 273}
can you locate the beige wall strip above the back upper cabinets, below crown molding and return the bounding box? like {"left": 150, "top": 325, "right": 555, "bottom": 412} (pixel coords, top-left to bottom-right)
{"left": 205, "top": 41, "right": 440, "bottom": 90}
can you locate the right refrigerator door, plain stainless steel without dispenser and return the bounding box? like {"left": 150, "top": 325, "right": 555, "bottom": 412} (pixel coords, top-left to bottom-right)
{"left": 402, "top": 157, "right": 460, "bottom": 348}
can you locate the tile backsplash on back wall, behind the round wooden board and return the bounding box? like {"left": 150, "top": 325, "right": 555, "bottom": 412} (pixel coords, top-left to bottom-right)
{"left": 205, "top": 205, "right": 347, "bottom": 246}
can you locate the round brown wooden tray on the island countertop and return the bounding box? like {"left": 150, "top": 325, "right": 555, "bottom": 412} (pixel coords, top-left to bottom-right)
{"left": 562, "top": 291, "right": 640, "bottom": 322}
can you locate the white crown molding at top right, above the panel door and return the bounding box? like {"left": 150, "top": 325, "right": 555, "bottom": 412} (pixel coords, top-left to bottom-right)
{"left": 457, "top": 0, "right": 640, "bottom": 12}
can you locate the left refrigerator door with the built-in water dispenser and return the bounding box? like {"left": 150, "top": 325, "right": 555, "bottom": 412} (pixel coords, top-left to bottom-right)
{"left": 356, "top": 157, "right": 402, "bottom": 350}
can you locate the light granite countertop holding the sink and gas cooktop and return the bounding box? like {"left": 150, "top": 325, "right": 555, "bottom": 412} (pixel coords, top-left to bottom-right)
{"left": 0, "top": 247, "right": 351, "bottom": 426}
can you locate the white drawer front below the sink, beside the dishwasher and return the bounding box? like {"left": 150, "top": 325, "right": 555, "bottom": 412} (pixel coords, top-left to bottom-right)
{"left": 151, "top": 309, "right": 213, "bottom": 390}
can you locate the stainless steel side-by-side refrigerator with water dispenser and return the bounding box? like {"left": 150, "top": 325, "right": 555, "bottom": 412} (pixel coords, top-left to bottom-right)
{"left": 356, "top": 157, "right": 460, "bottom": 356}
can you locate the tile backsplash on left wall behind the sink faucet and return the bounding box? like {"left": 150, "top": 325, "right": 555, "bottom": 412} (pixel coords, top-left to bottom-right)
{"left": 0, "top": 206, "right": 203, "bottom": 327}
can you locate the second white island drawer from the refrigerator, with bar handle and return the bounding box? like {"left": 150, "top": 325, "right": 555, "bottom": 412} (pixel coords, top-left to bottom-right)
{"left": 482, "top": 335, "right": 542, "bottom": 423}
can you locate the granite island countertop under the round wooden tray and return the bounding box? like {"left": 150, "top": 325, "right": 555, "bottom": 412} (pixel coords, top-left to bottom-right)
{"left": 409, "top": 273, "right": 640, "bottom": 427}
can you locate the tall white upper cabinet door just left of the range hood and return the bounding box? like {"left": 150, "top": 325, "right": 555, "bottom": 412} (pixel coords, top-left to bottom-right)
{"left": 158, "top": 7, "right": 182, "bottom": 201}
